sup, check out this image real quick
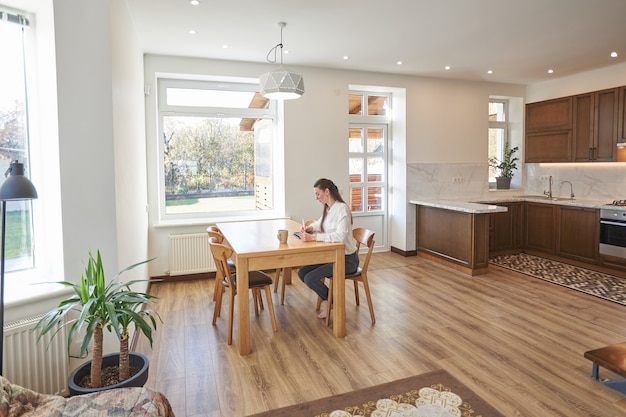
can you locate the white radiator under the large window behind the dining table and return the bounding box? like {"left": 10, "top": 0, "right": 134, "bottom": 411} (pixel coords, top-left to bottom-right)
{"left": 169, "top": 233, "right": 215, "bottom": 276}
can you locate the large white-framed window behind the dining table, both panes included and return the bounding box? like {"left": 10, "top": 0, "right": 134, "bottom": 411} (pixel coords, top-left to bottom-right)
{"left": 159, "top": 79, "right": 277, "bottom": 219}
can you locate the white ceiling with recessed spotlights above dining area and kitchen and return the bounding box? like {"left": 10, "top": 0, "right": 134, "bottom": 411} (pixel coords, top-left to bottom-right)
{"left": 126, "top": 0, "right": 626, "bottom": 84}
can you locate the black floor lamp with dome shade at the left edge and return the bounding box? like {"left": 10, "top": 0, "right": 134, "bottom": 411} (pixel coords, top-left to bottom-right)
{"left": 0, "top": 161, "right": 37, "bottom": 375}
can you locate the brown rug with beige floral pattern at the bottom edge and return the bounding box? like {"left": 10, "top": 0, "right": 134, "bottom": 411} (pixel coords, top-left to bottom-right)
{"left": 245, "top": 370, "right": 503, "bottom": 417}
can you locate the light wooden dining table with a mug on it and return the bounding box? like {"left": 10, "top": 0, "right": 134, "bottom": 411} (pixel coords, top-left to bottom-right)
{"left": 217, "top": 219, "right": 346, "bottom": 355}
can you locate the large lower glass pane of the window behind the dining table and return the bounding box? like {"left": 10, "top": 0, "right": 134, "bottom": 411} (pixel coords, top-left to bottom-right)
{"left": 163, "top": 116, "right": 272, "bottom": 214}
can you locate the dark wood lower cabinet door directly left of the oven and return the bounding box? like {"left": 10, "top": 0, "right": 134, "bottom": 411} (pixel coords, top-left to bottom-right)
{"left": 557, "top": 206, "right": 600, "bottom": 263}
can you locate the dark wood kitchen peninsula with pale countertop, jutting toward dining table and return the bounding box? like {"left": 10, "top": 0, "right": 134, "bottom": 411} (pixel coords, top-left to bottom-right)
{"left": 409, "top": 200, "right": 507, "bottom": 275}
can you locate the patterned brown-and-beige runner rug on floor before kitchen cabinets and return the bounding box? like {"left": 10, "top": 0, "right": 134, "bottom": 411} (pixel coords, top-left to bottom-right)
{"left": 489, "top": 253, "right": 626, "bottom": 305}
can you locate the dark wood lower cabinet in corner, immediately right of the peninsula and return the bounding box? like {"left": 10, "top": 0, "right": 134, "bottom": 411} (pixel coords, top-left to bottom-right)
{"left": 489, "top": 202, "right": 524, "bottom": 256}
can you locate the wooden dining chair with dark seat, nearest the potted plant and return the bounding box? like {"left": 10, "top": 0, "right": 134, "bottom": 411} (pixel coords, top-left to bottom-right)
{"left": 209, "top": 237, "right": 278, "bottom": 345}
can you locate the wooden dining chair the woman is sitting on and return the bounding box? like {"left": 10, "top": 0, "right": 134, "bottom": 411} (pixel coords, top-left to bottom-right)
{"left": 317, "top": 227, "right": 376, "bottom": 326}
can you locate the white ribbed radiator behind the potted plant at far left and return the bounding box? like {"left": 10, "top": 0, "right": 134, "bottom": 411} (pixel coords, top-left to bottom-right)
{"left": 3, "top": 316, "right": 69, "bottom": 396}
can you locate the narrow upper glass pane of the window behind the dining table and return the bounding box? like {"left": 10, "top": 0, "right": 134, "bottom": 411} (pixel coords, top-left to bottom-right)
{"left": 165, "top": 87, "right": 258, "bottom": 109}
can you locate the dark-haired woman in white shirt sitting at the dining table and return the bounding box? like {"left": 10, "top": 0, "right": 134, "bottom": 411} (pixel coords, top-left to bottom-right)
{"left": 298, "top": 178, "right": 359, "bottom": 319}
